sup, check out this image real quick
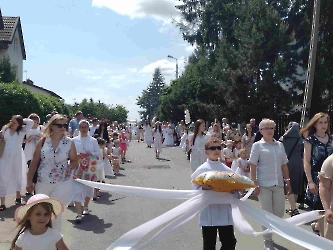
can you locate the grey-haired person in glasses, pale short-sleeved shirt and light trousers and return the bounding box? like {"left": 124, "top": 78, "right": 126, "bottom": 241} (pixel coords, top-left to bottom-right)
{"left": 249, "top": 119, "right": 291, "bottom": 250}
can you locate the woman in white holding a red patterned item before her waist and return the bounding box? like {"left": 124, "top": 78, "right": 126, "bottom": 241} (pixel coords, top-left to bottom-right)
{"left": 71, "top": 120, "right": 103, "bottom": 223}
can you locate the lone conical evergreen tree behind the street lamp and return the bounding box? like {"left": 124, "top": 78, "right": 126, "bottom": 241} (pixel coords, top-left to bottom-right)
{"left": 136, "top": 68, "right": 165, "bottom": 120}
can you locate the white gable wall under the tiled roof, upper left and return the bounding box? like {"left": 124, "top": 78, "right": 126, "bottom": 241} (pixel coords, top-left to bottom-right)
{"left": 0, "top": 28, "right": 23, "bottom": 83}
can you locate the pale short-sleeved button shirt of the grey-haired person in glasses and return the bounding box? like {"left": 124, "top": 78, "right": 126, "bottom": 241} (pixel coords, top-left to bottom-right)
{"left": 249, "top": 138, "right": 288, "bottom": 187}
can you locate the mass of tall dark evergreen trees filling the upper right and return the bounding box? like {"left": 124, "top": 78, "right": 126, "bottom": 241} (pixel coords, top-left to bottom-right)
{"left": 159, "top": 0, "right": 333, "bottom": 121}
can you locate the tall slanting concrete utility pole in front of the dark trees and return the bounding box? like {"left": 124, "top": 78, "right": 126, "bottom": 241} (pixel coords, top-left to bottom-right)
{"left": 300, "top": 0, "right": 320, "bottom": 127}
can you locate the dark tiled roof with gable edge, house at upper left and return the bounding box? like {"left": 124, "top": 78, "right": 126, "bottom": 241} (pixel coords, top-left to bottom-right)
{"left": 0, "top": 15, "right": 27, "bottom": 60}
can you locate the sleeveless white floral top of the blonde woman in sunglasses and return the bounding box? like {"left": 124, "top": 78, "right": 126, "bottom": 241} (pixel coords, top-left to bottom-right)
{"left": 37, "top": 136, "right": 71, "bottom": 184}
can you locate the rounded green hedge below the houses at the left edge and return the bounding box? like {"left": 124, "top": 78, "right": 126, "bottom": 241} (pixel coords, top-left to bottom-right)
{"left": 0, "top": 83, "right": 68, "bottom": 127}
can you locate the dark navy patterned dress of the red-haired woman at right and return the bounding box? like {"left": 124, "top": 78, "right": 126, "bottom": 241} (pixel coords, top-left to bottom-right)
{"left": 305, "top": 135, "right": 333, "bottom": 210}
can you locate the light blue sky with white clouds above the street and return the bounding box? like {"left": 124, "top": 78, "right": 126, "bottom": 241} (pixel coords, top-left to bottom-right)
{"left": 0, "top": 0, "right": 193, "bottom": 119}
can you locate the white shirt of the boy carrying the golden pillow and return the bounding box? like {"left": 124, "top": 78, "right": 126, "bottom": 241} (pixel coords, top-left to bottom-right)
{"left": 191, "top": 159, "right": 238, "bottom": 227}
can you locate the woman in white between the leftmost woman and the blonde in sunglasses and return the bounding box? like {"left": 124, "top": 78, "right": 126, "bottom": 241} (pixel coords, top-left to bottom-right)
{"left": 24, "top": 113, "right": 42, "bottom": 195}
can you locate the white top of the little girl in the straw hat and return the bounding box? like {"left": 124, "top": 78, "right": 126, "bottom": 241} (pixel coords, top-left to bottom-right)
{"left": 15, "top": 228, "right": 62, "bottom": 250}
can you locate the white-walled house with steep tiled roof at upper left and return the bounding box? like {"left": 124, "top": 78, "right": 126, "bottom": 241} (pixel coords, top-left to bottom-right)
{"left": 0, "top": 10, "right": 26, "bottom": 83}
